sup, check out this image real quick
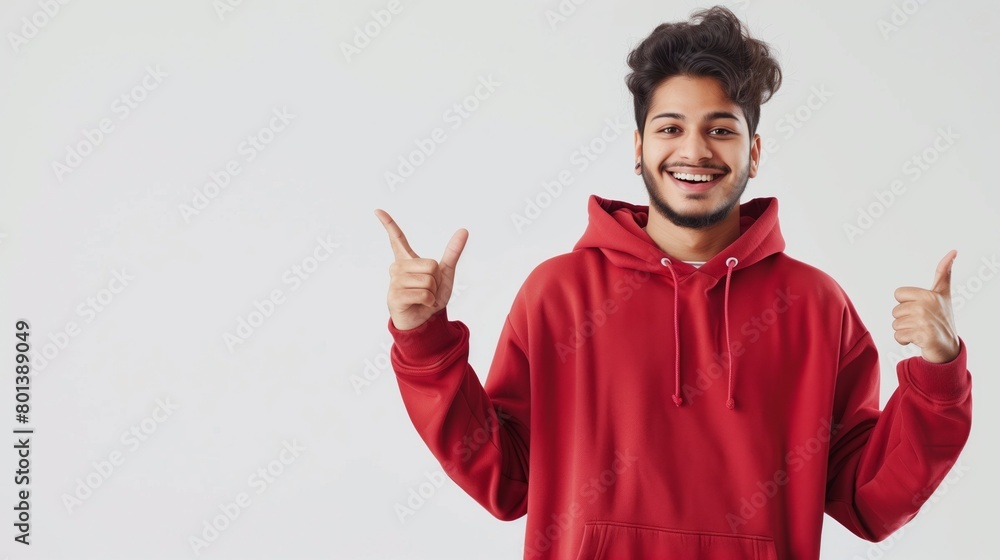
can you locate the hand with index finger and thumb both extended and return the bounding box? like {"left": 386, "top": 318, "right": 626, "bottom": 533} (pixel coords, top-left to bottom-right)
{"left": 375, "top": 208, "right": 469, "bottom": 331}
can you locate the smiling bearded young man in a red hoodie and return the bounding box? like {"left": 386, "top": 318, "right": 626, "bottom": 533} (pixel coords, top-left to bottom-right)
{"left": 376, "top": 7, "right": 972, "bottom": 560}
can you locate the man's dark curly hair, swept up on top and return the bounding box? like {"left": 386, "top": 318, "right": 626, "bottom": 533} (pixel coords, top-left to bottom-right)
{"left": 625, "top": 6, "right": 781, "bottom": 139}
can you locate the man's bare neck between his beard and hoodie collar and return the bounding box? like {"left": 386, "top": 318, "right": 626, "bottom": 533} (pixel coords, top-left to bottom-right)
{"left": 642, "top": 206, "right": 740, "bottom": 262}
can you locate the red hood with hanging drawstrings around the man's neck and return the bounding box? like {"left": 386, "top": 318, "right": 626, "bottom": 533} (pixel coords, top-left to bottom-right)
{"left": 573, "top": 194, "right": 785, "bottom": 409}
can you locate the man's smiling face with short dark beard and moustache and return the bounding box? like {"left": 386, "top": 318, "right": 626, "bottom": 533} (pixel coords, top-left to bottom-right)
{"left": 635, "top": 76, "right": 760, "bottom": 228}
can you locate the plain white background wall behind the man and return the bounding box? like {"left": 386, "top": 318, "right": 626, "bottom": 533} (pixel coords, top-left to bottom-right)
{"left": 0, "top": 0, "right": 1000, "bottom": 559}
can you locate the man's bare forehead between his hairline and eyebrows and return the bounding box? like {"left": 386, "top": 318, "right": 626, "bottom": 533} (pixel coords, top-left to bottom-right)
{"left": 647, "top": 75, "right": 743, "bottom": 119}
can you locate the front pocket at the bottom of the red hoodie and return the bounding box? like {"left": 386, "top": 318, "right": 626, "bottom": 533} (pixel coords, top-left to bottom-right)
{"left": 576, "top": 521, "right": 778, "bottom": 560}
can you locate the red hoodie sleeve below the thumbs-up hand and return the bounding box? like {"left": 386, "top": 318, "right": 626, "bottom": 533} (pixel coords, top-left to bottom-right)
{"left": 826, "top": 324, "right": 972, "bottom": 541}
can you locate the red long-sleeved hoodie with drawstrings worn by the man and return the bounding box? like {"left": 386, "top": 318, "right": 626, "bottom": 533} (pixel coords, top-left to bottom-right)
{"left": 388, "top": 195, "right": 972, "bottom": 560}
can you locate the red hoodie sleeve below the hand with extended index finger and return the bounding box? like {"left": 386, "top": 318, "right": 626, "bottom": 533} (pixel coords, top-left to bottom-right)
{"left": 388, "top": 294, "right": 530, "bottom": 521}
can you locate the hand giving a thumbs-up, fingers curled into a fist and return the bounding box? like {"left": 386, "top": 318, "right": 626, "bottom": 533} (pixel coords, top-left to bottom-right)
{"left": 892, "top": 249, "right": 960, "bottom": 364}
